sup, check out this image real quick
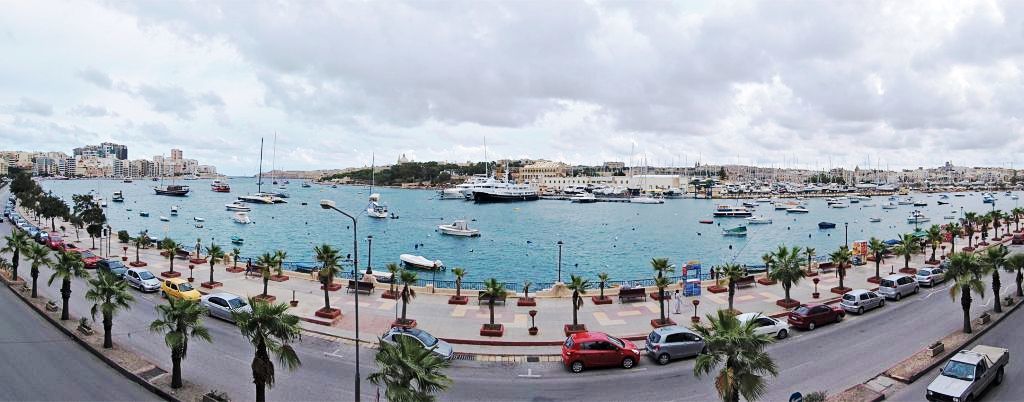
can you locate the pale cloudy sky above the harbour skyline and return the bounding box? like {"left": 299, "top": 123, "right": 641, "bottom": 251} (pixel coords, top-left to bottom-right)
{"left": 0, "top": 0, "right": 1024, "bottom": 174}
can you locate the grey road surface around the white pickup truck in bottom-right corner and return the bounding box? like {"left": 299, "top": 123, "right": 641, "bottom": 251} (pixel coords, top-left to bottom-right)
{"left": 886, "top": 292, "right": 1024, "bottom": 401}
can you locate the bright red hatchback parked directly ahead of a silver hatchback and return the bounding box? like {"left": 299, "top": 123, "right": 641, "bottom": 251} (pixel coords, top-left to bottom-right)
{"left": 562, "top": 332, "right": 640, "bottom": 372}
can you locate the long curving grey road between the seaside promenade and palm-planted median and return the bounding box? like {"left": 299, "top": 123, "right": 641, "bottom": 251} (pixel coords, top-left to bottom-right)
{"left": 0, "top": 193, "right": 1012, "bottom": 401}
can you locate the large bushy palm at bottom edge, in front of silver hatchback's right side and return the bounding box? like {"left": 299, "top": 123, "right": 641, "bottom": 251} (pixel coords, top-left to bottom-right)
{"left": 693, "top": 308, "right": 778, "bottom": 402}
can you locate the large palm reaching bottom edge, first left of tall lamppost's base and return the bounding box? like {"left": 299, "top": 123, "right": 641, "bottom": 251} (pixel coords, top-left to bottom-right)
{"left": 232, "top": 298, "right": 302, "bottom": 402}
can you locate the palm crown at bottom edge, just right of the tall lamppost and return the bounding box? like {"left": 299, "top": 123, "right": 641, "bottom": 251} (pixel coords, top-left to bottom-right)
{"left": 367, "top": 331, "right": 452, "bottom": 401}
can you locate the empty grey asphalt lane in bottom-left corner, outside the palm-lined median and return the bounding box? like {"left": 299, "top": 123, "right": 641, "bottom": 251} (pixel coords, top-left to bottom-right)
{"left": 0, "top": 286, "right": 155, "bottom": 401}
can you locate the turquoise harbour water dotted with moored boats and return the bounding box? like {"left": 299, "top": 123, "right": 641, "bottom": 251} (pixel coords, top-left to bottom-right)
{"left": 43, "top": 178, "right": 1017, "bottom": 283}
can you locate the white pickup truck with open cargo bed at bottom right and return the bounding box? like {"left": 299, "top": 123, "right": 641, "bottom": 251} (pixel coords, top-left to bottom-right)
{"left": 925, "top": 345, "right": 1010, "bottom": 402}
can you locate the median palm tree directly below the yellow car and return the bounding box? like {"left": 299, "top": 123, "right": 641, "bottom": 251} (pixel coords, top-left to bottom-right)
{"left": 150, "top": 296, "right": 213, "bottom": 389}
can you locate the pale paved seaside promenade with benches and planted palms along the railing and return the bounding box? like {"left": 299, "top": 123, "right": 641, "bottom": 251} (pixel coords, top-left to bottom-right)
{"left": 16, "top": 208, "right": 1009, "bottom": 355}
